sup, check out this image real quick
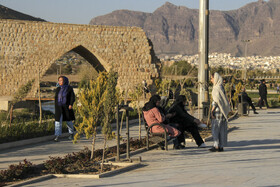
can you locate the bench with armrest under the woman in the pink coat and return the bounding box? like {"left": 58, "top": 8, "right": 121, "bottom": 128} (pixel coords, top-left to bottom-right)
{"left": 142, "top": 113, "right": 168, "bottom": 151}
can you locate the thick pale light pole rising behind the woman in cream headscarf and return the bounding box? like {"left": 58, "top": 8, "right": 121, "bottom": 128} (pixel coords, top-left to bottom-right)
{"left": 198, "top": 0, "right": 209, "bottom": 119}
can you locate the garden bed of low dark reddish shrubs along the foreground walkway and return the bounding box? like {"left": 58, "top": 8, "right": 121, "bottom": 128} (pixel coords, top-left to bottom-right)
{"left": 0, "top": 139, "right": 146, "bottom": 186}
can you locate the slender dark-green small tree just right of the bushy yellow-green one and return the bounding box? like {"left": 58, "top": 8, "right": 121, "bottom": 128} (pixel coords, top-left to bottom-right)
{"left": 101, "top": 71, "right": 118, "bottom": 172}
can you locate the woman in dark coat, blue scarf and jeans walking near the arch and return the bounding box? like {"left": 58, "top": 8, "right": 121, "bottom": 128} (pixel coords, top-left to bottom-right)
{"left": 54, "top": 76, "right": 75, "bottom": 141}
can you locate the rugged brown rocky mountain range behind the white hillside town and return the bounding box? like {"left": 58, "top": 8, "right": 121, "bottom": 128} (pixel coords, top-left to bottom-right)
{"left": 90, "top": 0, "right": 280, "bottom": 56}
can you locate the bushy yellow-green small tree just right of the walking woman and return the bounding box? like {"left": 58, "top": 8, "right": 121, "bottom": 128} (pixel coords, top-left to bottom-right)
{"left": 74, "top": 73, "right": 108, "bottom": 159}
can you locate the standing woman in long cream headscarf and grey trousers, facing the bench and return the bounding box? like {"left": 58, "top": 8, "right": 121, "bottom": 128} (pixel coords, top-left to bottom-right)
{"left": 209, "top": 73, "right": 230, "bottom": 152}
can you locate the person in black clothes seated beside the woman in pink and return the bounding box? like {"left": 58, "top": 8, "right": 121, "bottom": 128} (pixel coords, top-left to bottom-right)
{"left": 168, "top": 95, "right": 206, "bottom": 148}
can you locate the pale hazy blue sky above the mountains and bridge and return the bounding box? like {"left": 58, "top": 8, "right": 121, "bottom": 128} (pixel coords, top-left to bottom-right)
{"left": 0, "top": 0, "right": 262, "bottom": 24}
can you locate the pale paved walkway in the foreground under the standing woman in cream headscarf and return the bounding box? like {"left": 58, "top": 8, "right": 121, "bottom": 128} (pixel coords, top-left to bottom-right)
{"left": 0, "top": 109, "right": 280, "bottom": 187}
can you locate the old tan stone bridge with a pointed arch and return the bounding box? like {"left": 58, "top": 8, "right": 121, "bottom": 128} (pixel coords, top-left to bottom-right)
{"left": 0, "top": 19, "right": 158, "bottom": 97}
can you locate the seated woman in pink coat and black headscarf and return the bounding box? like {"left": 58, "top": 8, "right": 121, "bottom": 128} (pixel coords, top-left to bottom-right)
{"left": 143, "top": 95, "right": 181, "bottom": 147}
